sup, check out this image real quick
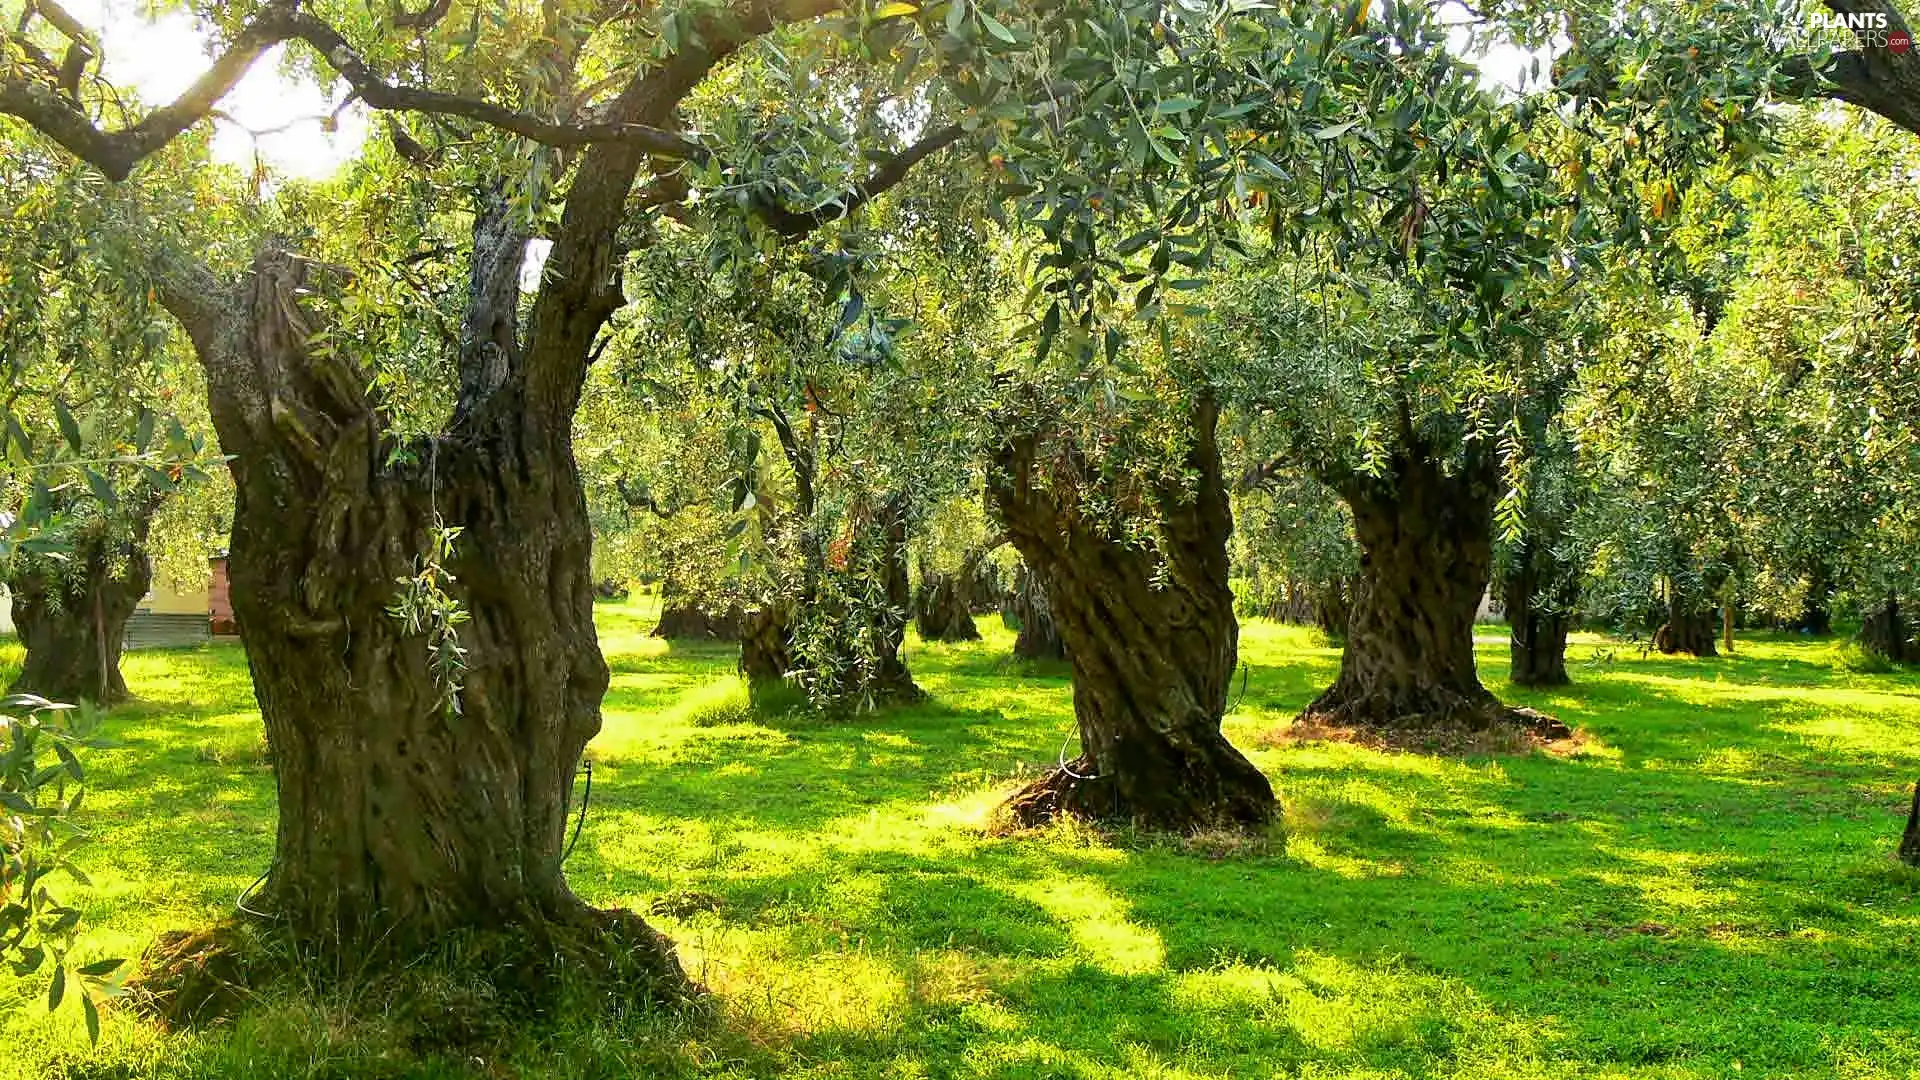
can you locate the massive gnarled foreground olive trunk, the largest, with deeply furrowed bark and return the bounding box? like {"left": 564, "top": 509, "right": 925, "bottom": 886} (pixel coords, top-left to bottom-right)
{"left": 165, "top": 222, "right": 687, "bottom": 995}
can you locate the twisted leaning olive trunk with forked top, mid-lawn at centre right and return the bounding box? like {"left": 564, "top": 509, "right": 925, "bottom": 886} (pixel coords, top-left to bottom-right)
{"left": 989, "top": 404, "right": 1275, "bottom": 832}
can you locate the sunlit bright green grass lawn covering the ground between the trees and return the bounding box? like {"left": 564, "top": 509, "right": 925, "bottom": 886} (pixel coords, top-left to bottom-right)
{"left": 0, "top": 605, "right": 1920, "bottom": 1080}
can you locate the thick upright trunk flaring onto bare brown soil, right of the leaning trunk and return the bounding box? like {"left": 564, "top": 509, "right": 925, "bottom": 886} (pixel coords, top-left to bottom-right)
{"left": 1302, "top": 452, "right": 1565, "bottom": 736}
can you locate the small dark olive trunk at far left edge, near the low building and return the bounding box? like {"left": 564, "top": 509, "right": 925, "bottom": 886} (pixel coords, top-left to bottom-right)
{"left": 8, "top": 507, "right": 154, "bottom": 705}
